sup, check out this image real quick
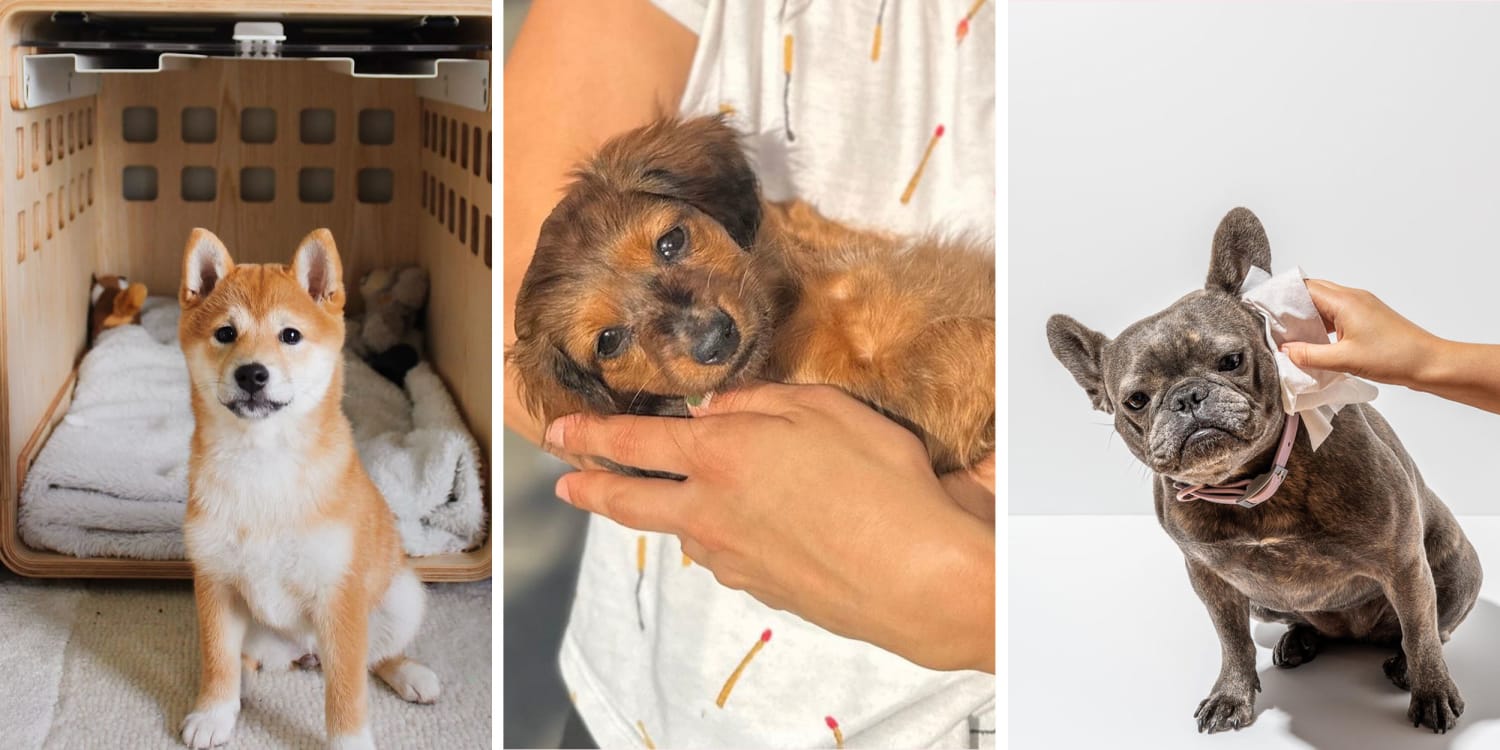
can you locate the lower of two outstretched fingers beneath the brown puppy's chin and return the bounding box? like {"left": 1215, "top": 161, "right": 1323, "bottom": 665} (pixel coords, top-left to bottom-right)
{"left": 555, "top": 471, "right": 690, "bottom": 534}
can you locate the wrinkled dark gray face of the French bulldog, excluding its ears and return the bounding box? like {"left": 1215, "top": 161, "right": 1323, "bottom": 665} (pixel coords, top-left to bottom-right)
{"left": 1101, "top": 291, "right": 1283, "bottom": 483}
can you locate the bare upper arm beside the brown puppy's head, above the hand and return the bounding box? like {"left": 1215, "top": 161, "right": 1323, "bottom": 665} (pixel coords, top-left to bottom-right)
{"left": 503, "top": 0, "right": 698, "bottom": 443}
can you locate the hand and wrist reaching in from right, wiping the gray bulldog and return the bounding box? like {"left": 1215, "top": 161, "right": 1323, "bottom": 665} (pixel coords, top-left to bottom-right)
{"left": 1281, "top": 279, "right": 1500, "bottom": 414}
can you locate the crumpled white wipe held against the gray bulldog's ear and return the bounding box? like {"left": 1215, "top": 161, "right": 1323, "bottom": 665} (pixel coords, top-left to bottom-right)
{"left": 1239, "top": 266, "right": 1380, "bottom": 450}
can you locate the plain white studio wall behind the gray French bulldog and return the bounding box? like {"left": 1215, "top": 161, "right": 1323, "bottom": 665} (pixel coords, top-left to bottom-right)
{"left": 1008, "top": 3, "right": 1500, "bottom": 515}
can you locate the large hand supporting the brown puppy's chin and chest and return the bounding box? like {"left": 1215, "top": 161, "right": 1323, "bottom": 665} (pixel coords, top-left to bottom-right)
{"left": 548, "top": 384, "right": 995, "bottom": 672}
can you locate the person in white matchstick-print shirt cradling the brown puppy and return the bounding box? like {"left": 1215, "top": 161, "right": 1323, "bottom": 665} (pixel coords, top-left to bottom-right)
{"left": 504, "top": 0, "right": 996, "bottom": 747}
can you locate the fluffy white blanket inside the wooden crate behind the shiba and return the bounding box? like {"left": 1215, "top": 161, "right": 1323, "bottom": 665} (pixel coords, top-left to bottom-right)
{"left": 20, "top": 297, "right": 485, "bottom": 560}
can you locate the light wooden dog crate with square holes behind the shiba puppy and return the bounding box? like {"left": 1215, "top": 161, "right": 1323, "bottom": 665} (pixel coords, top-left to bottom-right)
{"left": 0, "top": 0, "right": 494, "bottom": 581}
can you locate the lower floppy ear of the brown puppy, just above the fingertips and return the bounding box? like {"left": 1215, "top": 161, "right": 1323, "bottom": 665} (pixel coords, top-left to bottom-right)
{"left": 506, "top": 336, "right": 617, "bottom": 435}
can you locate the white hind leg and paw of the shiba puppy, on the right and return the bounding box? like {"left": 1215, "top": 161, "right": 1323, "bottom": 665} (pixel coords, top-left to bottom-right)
{"left": 371, "top": 569, "right": 443, "bottom": 704}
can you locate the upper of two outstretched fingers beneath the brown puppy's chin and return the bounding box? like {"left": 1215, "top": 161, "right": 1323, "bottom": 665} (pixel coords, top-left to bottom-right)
{"left": 546, "top": 414, "right": 702, "bottom": 476}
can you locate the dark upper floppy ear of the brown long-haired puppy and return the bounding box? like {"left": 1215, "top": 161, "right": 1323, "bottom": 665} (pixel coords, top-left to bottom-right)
{"left": 597, "top": 116, "right": 761, "bottom": 249}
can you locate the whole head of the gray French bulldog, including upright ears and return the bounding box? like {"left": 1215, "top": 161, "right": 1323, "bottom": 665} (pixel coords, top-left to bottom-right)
{"left": 1047, "top": 209, "right": 1284, "bottom": 485}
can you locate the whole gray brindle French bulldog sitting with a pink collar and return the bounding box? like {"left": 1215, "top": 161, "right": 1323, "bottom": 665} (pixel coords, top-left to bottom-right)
{"left": 1047, "top": 209, "right": 1482, "bottom": 732}
